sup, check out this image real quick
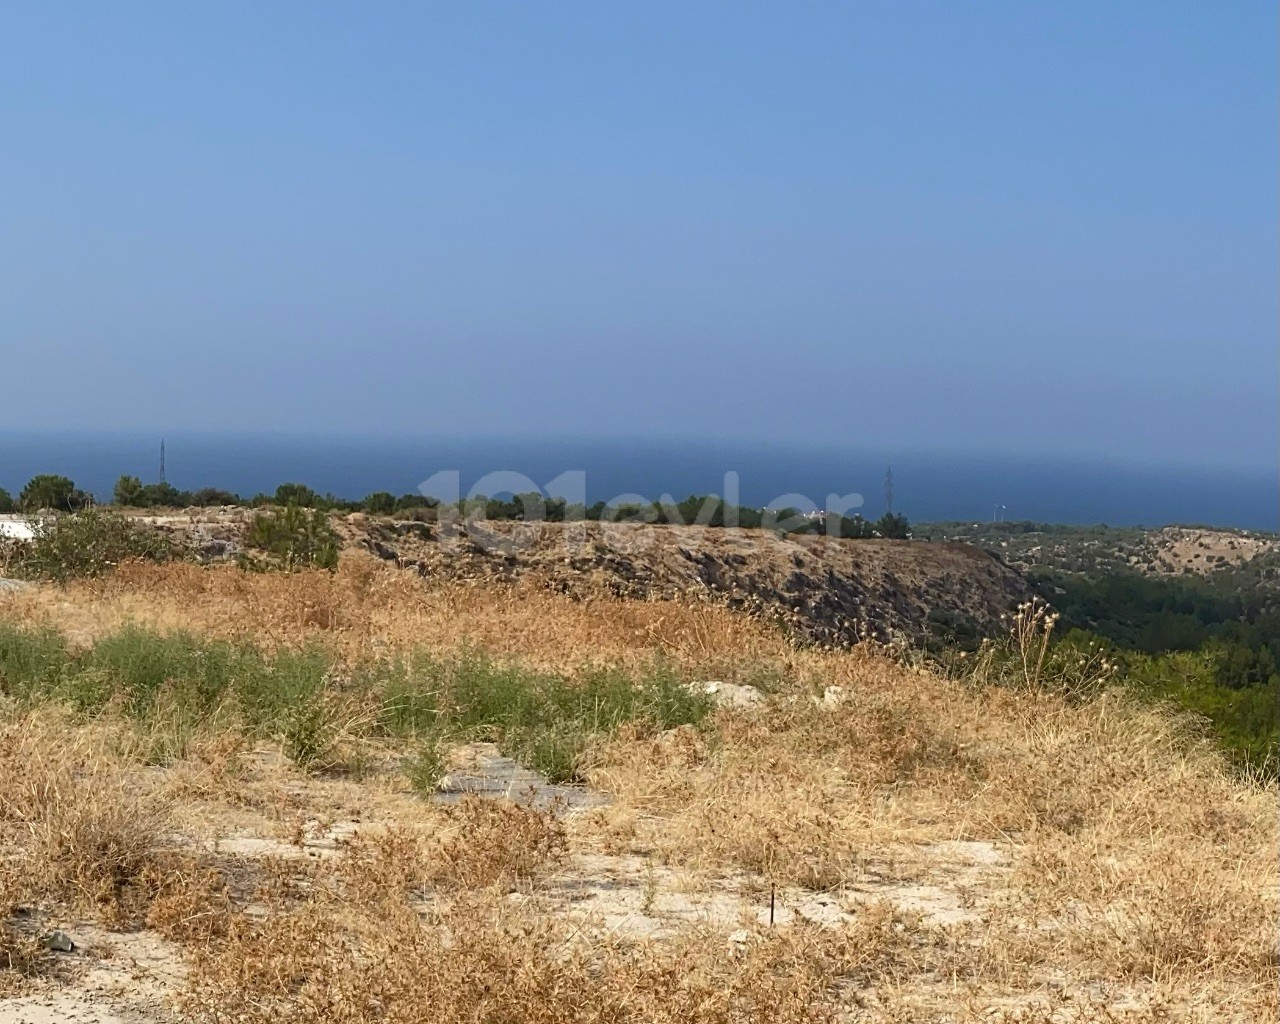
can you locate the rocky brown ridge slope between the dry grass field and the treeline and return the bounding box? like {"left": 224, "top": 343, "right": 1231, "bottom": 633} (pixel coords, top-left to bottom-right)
{"left": 122, "top": 509, "right": 1030, "bottom": 644}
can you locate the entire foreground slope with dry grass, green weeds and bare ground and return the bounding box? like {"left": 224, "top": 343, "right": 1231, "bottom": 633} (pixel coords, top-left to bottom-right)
{"left": 0, "top": 560, "right": 1280, "bottom": 1024}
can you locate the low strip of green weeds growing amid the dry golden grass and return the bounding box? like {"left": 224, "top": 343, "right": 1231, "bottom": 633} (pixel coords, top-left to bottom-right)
{"left": 0, "top": 623, "right": 710, "bottom": 791}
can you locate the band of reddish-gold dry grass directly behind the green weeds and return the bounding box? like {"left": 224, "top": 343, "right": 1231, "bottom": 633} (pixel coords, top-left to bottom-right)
{"left": 4, "top": 552, "right": 790, "bottom": 671}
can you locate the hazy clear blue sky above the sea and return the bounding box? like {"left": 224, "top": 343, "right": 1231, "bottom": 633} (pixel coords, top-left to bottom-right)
{"left": 0, "top": 0, "right": 1277, "bottom": 465}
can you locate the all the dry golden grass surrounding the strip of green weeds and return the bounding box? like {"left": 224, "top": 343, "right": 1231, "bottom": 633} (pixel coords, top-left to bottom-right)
{"left": 0, "top": 559, "right": 1280, "bottom": 1024}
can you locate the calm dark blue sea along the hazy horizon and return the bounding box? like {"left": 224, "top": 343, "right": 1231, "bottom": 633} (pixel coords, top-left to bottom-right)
{"left": 0, "top": 431, "right": 1280, "bottom": 530}
